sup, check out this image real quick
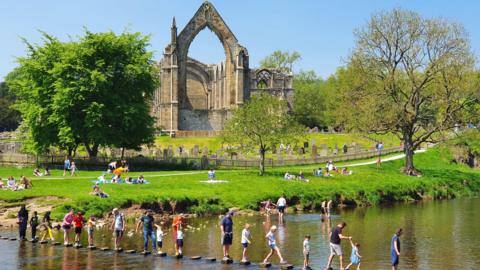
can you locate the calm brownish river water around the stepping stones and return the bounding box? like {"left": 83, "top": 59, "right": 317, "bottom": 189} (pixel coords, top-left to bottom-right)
{"left": 0, "top": 199, "right": 480, "bottom": 270}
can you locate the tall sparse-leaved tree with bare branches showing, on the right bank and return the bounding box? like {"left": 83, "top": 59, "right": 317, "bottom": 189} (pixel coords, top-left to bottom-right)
{"left": 343, "top": 9, "right": 478, "bottom": 172}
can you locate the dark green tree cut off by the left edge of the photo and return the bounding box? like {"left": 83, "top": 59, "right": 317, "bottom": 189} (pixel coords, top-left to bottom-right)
{"left": 0, "top": 82, "right": 21, "bottom": 132}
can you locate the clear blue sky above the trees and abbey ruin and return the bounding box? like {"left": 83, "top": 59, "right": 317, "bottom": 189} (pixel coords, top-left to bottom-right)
{"left": 0, "top": 0, "right": 480, "bottom": 80}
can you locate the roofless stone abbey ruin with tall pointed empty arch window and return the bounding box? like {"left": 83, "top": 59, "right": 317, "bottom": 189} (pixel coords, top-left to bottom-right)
{"left": 152, "top": 2, "right": 293, "bottom": 134}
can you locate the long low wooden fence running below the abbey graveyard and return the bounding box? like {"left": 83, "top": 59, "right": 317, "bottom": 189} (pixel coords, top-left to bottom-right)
{"left": 0, "top": 147, "right": 403, "bottom": 171}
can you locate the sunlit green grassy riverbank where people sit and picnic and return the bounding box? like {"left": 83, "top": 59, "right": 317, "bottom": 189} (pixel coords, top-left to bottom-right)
{"left": 0, "top": 149, "right": 480, "bottom": 217}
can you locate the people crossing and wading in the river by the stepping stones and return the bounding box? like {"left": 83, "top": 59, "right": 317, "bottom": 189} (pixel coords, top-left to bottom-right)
{"left": 18, "top": 199, "right": 403, "bottom": 270}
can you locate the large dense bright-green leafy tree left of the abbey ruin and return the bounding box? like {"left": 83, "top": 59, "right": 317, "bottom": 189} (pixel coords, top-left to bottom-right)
{"left": 8, "top": 31, "right": 158, "bottom": 157}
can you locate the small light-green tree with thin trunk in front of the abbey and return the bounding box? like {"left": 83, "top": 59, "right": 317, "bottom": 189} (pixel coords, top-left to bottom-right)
{"left": 222, "top": 93, "right": 304, "bottom": 175}
